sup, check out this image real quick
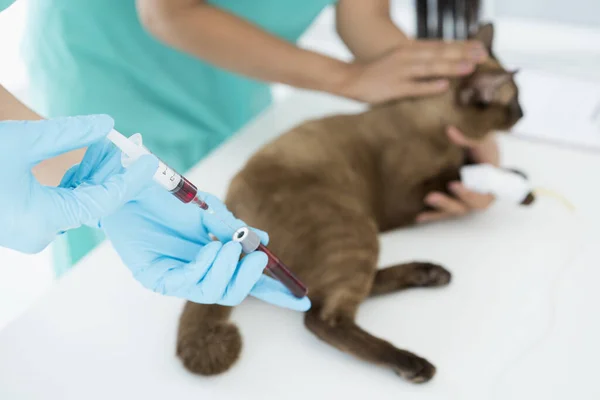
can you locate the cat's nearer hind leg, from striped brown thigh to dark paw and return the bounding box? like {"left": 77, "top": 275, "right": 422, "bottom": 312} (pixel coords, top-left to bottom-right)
{"left": 304, "top": 211, "right": 435, "bottom": 383}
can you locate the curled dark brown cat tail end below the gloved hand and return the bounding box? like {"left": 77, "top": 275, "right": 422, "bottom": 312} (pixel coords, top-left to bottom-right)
{"left": 177, "top": 302, "right": 242, "bottom": 375}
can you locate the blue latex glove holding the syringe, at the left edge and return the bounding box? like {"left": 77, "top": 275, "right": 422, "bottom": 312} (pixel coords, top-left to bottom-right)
{"left": 0, "top": 115, "right": 157, "bottom": 253}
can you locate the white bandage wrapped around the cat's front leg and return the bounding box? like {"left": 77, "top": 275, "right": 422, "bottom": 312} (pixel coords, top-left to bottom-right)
{"left": 460, "top": 164, "right": 533, "bottom": 204}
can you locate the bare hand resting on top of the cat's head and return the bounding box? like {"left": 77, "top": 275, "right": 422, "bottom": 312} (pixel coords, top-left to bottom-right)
{"left": 333, "top": 40, "right": 488, "bottom": 104}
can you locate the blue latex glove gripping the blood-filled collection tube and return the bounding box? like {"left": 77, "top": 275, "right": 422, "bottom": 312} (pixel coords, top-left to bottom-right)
{"left": 62, "top": 144, "right": 310, "bottom": 311}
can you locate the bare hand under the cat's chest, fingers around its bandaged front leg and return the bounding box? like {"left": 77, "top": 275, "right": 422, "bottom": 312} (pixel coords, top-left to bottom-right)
{"left": 417, "top": 127, "right": 500, "bottom": 223}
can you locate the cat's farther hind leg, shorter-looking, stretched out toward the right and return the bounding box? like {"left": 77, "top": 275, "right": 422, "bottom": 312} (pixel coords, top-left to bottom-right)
{"left": 370, "top": 262, "right": 452, "bottom": 296}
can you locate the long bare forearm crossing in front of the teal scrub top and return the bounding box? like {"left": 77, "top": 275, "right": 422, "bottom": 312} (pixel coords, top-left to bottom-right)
{"left": 137, "top": 0, "right": 346, "bottom": 91}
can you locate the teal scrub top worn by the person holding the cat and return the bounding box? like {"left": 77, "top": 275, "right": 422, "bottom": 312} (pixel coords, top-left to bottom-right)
{"left": 22, "top": 0, "right": 335, "bottom": 275}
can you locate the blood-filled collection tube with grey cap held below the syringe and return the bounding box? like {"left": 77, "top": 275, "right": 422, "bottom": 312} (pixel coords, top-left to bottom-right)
{"left": 233, "top": 227, "right": 308, "bottom": 298}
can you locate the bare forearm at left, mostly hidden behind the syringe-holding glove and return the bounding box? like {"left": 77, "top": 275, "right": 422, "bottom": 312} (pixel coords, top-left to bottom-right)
{"left": 0, "top": 85, "right": 85, "bottom": 186}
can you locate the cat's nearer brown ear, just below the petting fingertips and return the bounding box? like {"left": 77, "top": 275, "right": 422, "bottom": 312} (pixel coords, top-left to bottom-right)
{"left": 458, "top": 71, "right": 517, "bottom": 106}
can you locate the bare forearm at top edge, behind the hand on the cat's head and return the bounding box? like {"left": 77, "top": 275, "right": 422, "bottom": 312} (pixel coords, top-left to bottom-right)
{"left": 336, "top": 0, "right": 408, "bottom": 62}
